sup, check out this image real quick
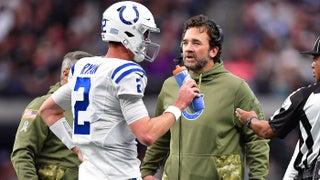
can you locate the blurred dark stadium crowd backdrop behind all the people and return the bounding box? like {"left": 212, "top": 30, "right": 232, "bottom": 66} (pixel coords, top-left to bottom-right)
{"left": 0, "top": 0, "right": 320, "bottom": 180}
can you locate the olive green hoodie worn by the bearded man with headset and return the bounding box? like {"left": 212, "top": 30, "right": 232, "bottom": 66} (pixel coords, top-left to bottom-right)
{"left": 141, "top": 60, "right": 269, "bottom": 180}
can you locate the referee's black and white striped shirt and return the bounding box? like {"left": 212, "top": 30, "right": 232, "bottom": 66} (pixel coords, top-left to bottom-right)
{"left": 269, "top": 83, "right": 320, "bottom": 174}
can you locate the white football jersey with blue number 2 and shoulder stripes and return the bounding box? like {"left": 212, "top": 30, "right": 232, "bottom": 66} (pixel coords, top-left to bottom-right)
{"left": 52, "top": 57, "right": 148, "bottom": 179}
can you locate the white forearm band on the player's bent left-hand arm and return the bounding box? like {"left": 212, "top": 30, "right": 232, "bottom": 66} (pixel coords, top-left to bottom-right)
{"left": 49, "top": 117, "right": 75, "bottom": 150}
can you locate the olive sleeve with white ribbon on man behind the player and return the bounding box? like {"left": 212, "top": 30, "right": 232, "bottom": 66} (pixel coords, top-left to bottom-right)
{"left": 11, "top": 98, "right": 48, "bottom": 180}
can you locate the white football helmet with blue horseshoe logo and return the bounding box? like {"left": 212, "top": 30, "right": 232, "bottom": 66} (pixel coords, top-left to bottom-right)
{"left": 101, "top": 1, "right": 160, "bottom": 62}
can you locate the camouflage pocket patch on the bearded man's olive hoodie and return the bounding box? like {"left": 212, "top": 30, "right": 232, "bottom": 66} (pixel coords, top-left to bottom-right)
{"left": 213, "top": 155, "right": 241, "bottom": 180}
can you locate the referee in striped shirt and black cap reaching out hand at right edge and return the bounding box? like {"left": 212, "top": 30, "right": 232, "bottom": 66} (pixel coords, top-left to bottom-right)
{"left": 236, "top": 36, "right": 320, "bottom": 180}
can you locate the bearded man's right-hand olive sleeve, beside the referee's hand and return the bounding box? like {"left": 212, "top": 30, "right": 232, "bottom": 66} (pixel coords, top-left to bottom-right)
{"left": 234, "top": 83, "right": 270, "bottom": 180}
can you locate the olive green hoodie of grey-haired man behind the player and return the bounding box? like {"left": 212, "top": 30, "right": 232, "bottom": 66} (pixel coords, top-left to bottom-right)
{"left": 11, "top": 83, "right": 80, "bottom": 180}
